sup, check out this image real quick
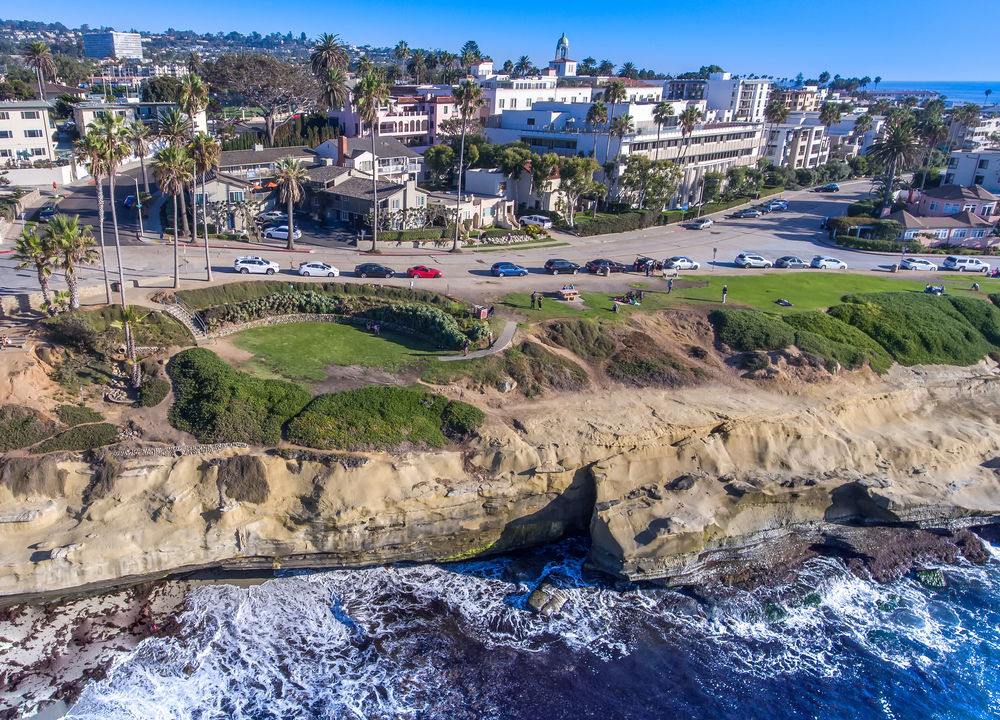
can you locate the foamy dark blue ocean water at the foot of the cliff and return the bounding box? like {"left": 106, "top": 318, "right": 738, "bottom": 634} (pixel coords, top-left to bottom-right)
{"left": 60, "top": 540, "right": 1000, "bottom": 720}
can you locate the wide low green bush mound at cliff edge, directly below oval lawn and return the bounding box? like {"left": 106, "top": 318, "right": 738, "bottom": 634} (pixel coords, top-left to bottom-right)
{"left": 288, "top": 385, "right": 482, "bottom": 450}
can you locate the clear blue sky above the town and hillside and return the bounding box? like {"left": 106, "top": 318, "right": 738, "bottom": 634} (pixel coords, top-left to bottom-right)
{"left": 15, "top": 0, "right": 1000, "bottom": 80}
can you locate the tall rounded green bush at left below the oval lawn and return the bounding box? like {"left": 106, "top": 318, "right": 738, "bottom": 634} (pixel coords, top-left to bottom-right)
{"left": 167, "top": 348, "right": 310, "bottom": 445}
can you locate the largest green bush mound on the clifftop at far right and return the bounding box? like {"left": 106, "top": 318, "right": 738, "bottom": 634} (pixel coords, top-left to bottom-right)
{"left": 829, "top": 293, "right": 994, "bottom": 365}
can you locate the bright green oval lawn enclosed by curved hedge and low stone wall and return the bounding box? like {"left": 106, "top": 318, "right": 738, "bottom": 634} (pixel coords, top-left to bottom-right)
{"left": 233, "top": 323, "right": 451, "bottom": 381}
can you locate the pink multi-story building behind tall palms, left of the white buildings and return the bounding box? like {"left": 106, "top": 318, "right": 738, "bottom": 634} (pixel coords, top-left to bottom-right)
{"left": 329, "top": 85, "right": 456, "bottom": 146}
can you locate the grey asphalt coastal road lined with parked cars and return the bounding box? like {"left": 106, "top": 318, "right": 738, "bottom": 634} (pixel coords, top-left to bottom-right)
{"left": 0, "top": 180, "right": 990, "bottom": 299}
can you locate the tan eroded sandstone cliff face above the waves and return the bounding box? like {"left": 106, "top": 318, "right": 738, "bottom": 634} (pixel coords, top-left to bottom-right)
{"left": 0, "top": 365, "right": 1000, "bottom": 601}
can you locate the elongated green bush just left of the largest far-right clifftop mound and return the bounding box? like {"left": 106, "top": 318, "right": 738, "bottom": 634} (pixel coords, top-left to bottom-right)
{"left": 785, "top": 311, "right": 892, "bottom": 373}
